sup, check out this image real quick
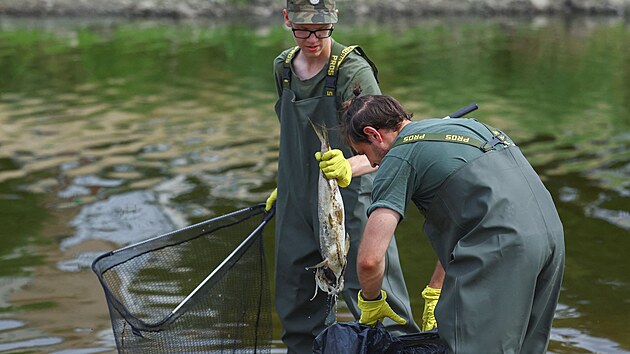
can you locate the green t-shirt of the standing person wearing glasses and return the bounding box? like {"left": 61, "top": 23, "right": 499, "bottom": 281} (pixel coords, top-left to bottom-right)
{"left": 273, "top": 41, "right": 381, "bottom": 102}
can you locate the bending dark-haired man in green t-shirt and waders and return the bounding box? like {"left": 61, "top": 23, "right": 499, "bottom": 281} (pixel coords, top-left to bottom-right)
{"left": 343, "top": 95, "right": 565, "bottom": 354}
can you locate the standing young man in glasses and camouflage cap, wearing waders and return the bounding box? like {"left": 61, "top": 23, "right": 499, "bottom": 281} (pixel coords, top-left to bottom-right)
{"left": 267, "top": 0, "right": 418, "bottom": 354}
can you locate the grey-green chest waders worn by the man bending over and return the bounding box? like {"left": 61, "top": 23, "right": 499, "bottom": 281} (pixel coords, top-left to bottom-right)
{"left": 399, "top": 128, "right": 565, "bottom": 354}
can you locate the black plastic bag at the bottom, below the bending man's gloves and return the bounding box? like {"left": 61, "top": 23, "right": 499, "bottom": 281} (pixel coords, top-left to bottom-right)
{"left": 313, "top": 321, "right": 448, "bottom": 354}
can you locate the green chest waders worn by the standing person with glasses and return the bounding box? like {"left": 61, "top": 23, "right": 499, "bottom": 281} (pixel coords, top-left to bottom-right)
{"left": 275, "top": 42, "right": 417, "bottom": 353}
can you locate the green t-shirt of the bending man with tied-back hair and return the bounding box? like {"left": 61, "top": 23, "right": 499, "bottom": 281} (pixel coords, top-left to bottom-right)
{"left": 368, "top": 118, "right": 512, "bottom": 220}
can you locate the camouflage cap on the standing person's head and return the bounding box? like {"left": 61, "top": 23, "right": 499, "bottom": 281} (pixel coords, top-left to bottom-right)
{"left": 287, "top": 0, "right": 337, "bottom": 24}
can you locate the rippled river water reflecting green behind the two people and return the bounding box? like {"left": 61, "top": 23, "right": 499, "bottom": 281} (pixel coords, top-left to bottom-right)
{"left": 0, "top": 14, "right": 630, "bottom": 354}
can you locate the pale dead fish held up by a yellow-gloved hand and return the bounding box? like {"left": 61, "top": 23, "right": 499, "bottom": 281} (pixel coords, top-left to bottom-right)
{"left": 306, "top": 122, "right": 350, "bottom": 300}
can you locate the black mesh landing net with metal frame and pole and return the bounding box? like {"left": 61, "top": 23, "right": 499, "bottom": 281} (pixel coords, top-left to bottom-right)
{"left": 92, "top": 205, "right": 273, "bottom": 354}
